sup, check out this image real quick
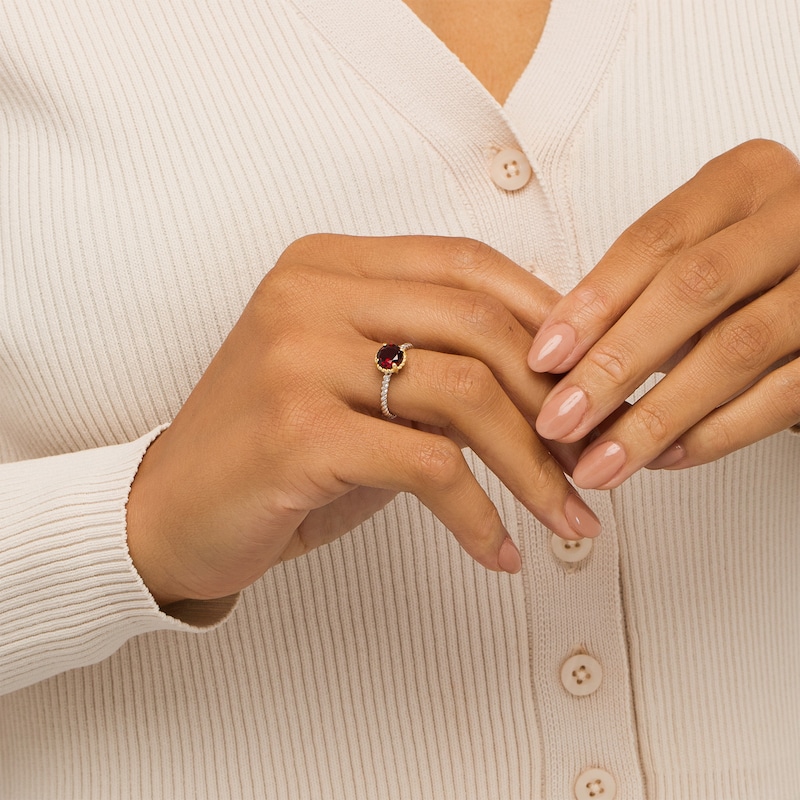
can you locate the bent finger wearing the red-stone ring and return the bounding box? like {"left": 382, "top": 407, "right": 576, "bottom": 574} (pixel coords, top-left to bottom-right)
{"left": 332, "top": 345, "right": 599, "bottom": 539}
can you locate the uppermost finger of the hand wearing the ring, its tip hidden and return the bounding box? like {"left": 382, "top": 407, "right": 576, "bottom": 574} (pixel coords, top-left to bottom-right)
{"left": 292, "top": 234, "right": 560, "bottom": 333}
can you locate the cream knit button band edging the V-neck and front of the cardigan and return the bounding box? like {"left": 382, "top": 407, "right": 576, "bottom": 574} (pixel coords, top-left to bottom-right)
{"left": 282, "top": 0, "right": 643, "bottom": 800}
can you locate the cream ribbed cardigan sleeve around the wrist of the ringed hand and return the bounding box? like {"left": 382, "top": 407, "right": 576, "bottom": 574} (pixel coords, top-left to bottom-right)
{"left": 0, "top": 428, "right": 236, "bottom": 694}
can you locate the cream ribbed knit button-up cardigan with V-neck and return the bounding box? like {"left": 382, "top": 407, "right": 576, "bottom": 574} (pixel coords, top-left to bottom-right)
{"left": 0, "top": 0, "right": 800, "bottom": 800}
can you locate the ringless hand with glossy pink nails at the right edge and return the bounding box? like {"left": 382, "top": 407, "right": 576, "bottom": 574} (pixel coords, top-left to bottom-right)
{"left": 528, "top": 140, "right": 800, "bottom": 489}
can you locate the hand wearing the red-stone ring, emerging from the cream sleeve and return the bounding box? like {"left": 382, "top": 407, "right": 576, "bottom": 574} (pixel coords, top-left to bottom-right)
{"left": 128, "top": 234, "right": 599, "bottom": 605}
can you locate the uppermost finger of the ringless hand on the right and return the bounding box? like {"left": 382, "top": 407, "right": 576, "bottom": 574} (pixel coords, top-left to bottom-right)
{"left": 528, "top": 140, "right": 799, "bottom": 373}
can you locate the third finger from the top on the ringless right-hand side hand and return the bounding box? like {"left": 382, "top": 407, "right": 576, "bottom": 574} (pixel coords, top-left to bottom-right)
{"left": 574, "top": 274, "right": 800, "bottom": 488}
